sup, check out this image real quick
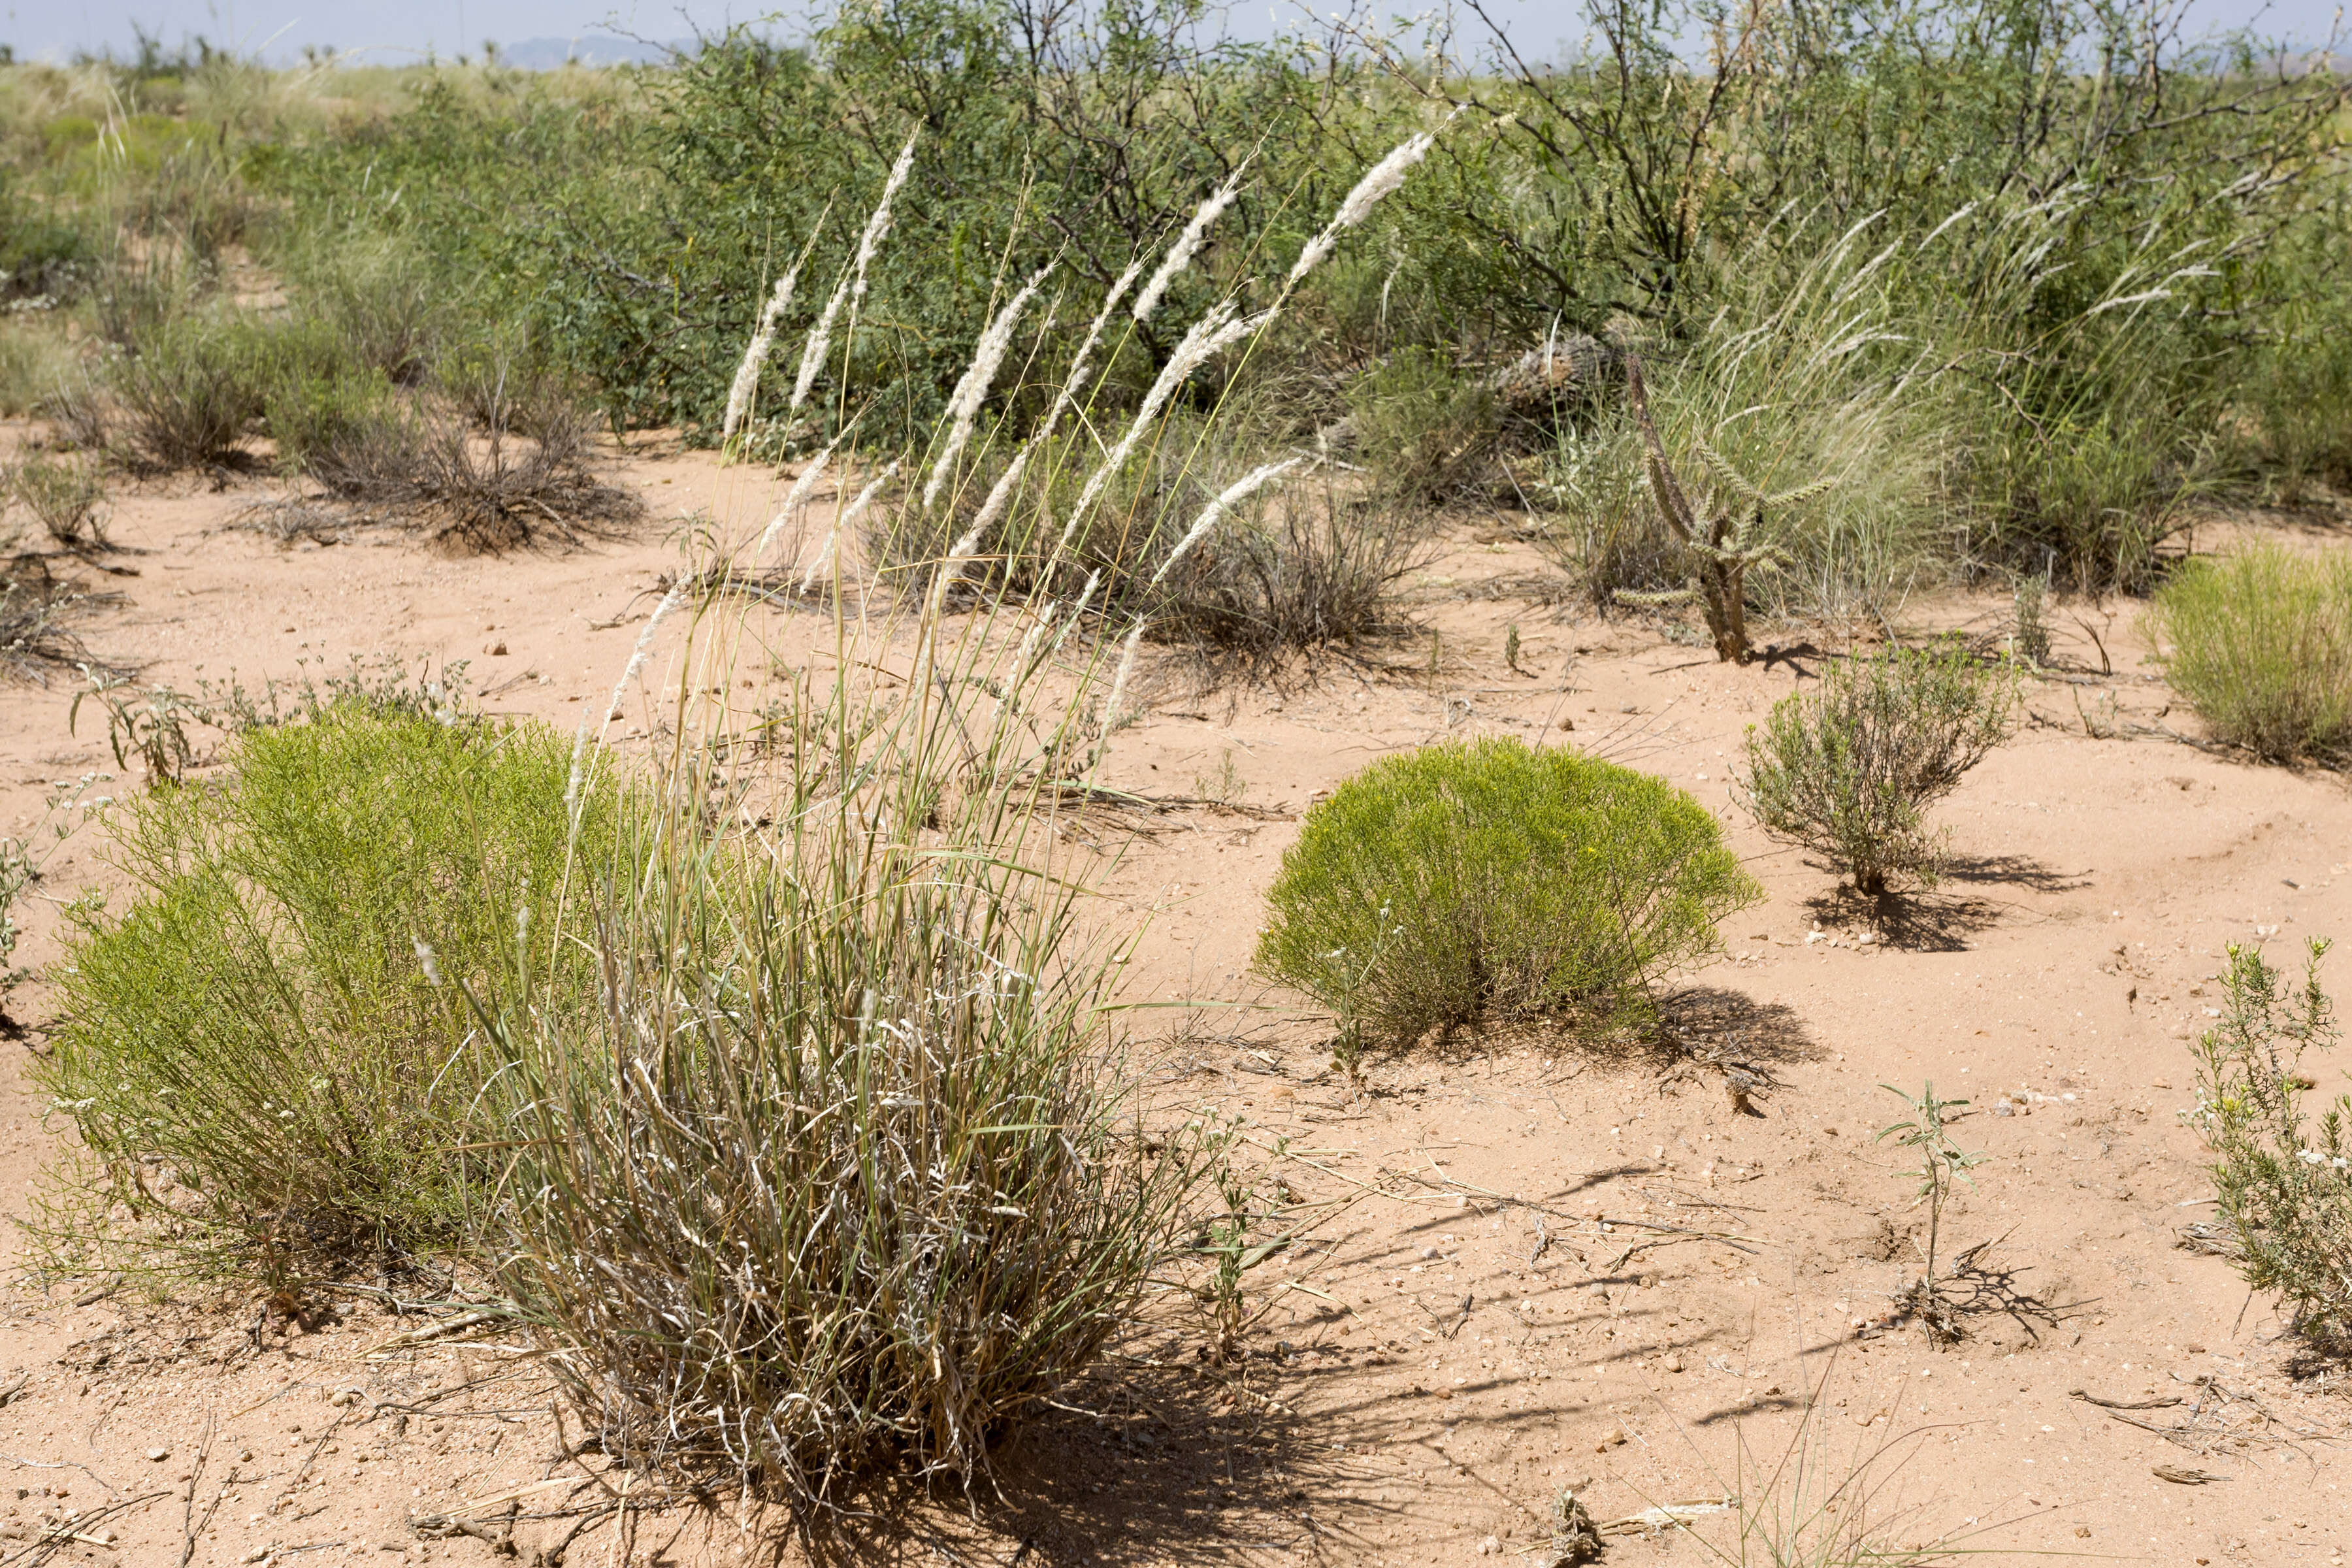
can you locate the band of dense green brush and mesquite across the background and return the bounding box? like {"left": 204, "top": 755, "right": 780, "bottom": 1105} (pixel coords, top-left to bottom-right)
{"left": 0, "top": 0, "right": 2352, "bottom": 620}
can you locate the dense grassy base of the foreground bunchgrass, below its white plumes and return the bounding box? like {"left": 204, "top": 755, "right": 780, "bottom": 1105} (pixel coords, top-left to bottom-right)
{"left": 485, "top": 623, "right": 1190, "bottom": 1509}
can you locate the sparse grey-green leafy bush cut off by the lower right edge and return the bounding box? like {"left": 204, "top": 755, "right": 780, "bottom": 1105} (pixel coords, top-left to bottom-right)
{"left": 2183, "top": 940, "right": 2352, "bottom": 1343}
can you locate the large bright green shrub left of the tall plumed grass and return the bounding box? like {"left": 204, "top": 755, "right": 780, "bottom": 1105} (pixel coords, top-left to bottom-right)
{"left": 35, "top": 698, "right": 614, "bottom": 1279}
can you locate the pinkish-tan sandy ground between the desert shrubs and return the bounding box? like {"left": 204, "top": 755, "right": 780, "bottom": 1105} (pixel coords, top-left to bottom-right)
{"left": 0, "top": 440, "right": 2352, "bottom": 1565}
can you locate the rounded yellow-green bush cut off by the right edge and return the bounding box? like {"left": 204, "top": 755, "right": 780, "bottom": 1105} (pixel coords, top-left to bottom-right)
{"left": 2152, "top": 546, "right": 2352, "bottom": 764}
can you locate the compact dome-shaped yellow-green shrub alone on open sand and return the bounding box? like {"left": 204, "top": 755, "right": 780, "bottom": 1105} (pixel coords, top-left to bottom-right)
{"left": 1256, "top": 740, "right": 1761, "bottom": 1041}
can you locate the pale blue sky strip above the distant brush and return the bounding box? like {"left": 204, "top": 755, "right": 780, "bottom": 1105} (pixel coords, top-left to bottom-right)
{"left": 0, "top": 0, "right": 2336, "bottom": 61}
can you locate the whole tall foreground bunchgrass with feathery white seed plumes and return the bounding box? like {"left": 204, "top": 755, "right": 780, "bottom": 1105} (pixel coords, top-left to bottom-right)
{"left": 482, "top": 110, "right": 1426, "bottom": 1514}
